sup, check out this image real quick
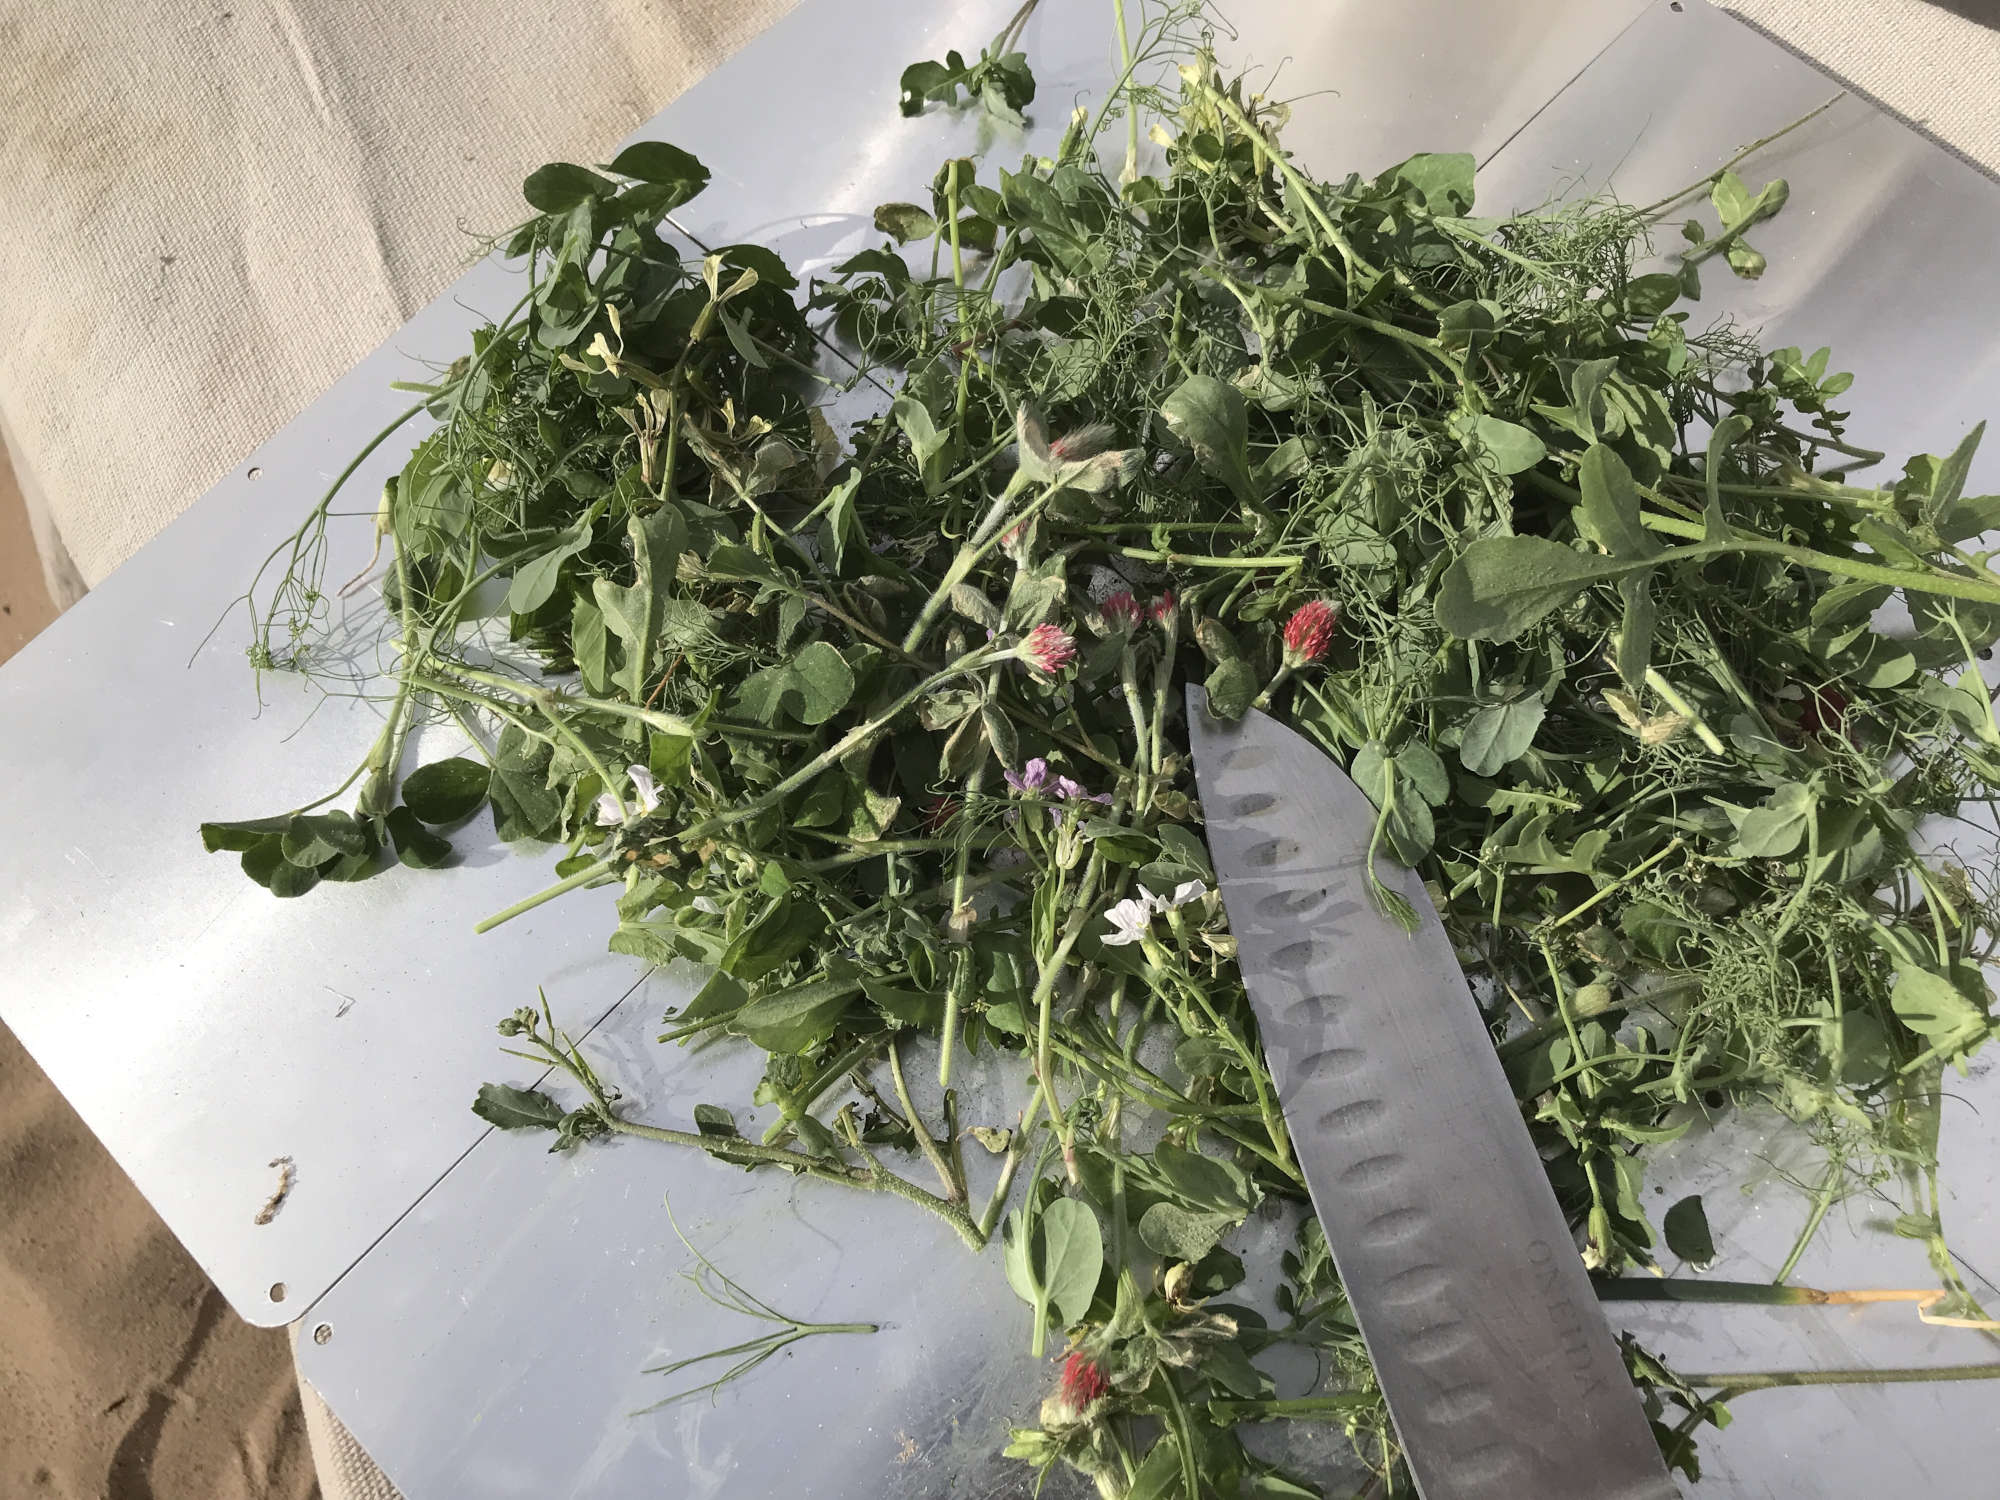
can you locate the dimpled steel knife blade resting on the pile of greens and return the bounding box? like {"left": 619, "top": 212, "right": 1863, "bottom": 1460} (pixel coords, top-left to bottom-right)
{"left": 1188, "top": 688, "right": 1678, "bottom": 1500}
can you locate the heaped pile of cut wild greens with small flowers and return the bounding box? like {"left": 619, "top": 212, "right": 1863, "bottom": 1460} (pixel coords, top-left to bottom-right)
{"left": 204, "top": 6, "right": 2000, "bottom": 1500}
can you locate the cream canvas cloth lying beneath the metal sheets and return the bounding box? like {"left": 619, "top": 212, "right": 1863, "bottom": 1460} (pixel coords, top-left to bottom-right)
{"left": 0, "top": 0, "right": 2000, "bottom": 1500}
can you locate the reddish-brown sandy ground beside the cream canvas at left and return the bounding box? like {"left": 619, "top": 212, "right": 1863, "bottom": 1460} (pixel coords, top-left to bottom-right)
{"left": 0, "top": 454, "right": 320, "bottom": 1500}
